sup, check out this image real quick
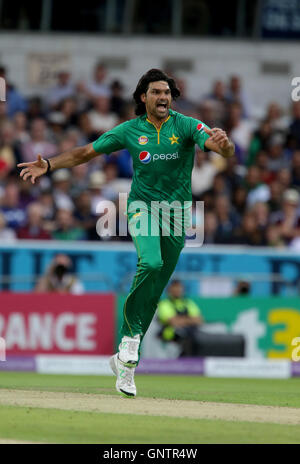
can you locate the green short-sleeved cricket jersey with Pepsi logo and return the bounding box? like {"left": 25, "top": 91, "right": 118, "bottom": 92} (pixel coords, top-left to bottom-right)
{"left": 93, "top": 110, "right": 209, "bottom": 205}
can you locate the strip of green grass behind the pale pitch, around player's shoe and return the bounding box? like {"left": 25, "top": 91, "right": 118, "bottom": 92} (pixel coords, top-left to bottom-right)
{"left": 0, "top": 372, "right": 300, "bottom": 408}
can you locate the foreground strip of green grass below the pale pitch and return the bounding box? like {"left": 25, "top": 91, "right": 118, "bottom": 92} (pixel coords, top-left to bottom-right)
{"left": 0, "top": 406, "right": 300, "bottom": 444}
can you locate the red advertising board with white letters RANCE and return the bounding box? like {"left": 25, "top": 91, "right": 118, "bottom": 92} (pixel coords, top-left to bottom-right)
{"left": 0, "top": 293, "right": 115, "bottom": 355}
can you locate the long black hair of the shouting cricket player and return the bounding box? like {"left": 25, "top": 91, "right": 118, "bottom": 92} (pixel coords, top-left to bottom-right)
{"left": 133, "top": 69, "right": 180, "bottom": 116}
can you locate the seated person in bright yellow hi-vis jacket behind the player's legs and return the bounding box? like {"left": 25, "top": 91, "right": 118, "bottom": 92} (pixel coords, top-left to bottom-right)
{"left": 157, "top": 280, "right": 203, "bottom": 356}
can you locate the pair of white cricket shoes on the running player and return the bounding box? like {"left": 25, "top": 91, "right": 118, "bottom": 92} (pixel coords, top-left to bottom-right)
{"left": 109, "top": 335, "right": 140, "bottom": 396}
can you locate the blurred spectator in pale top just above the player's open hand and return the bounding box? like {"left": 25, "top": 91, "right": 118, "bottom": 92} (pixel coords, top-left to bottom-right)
{"left": 21, "top": 119, "right": 57, "bottom": 162}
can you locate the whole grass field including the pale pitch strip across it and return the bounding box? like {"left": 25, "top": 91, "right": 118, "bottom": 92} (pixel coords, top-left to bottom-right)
{"left": 0, "top": 372, "right": 300, "bottom": 444}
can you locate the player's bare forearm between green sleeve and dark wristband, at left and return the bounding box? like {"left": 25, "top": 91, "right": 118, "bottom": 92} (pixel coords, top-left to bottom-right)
{"left": 49, "top": 143, "right": 98, "bottom": 171}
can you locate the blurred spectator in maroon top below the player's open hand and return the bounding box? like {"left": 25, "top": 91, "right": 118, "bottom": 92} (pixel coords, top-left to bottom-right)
{"left": 17, "top": 202, "right": 51, "bottom": 240}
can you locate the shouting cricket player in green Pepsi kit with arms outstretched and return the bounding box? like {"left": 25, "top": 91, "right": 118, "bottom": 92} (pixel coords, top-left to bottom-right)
{"left": 18, "top": 69, "right": 234, "bottom": 397}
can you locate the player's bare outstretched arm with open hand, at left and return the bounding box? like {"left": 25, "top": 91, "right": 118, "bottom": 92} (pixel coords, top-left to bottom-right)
{"left": 17, "top": 143, "right": 99, "bottom": 184}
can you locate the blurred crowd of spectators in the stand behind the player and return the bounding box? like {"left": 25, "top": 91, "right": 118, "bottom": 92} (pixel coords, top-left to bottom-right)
{"left": 0, "top": 63, "right": 300, "bottom": 249}
